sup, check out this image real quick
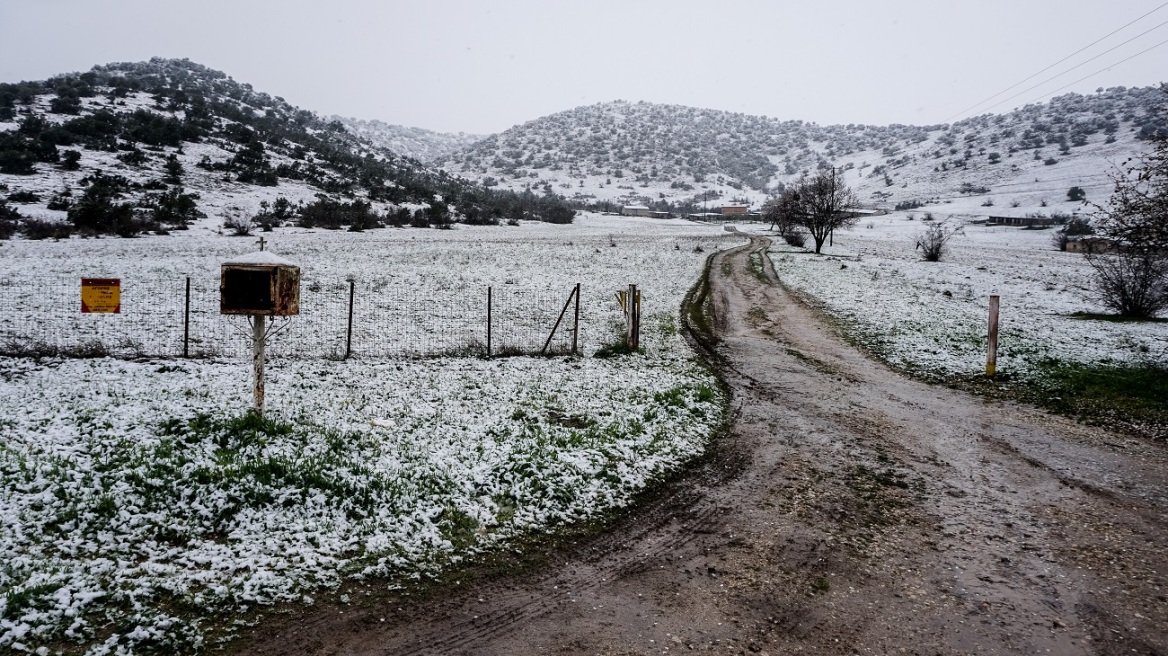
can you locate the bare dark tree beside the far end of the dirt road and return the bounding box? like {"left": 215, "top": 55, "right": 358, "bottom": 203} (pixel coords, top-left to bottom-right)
{"left": 769, "top": 167, "right": 858, "bottom": 253}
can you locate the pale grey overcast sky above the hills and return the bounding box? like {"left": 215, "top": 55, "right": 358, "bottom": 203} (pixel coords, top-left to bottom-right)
{"left": 0, "top": 0, "right": 1168, "bottom": 134}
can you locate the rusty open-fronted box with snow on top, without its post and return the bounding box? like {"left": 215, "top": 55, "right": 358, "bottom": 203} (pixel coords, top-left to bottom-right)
{"left": 220, "top": 251, "right": 300, "bottom": 316}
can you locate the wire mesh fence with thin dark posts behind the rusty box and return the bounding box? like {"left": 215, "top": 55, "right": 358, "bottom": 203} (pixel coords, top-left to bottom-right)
{"left": 0, "top": 277, "right": 602, "bottom": 358}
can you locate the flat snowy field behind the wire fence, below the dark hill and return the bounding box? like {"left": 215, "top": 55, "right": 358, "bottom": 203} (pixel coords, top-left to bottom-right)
{"left": 0, "top": 204, "right": 726, "bottom": 358}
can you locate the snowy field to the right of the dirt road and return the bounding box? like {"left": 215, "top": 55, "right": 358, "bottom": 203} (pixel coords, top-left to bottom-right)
{"left": 742, "top": 210, "right": 1168, "bottom": 379}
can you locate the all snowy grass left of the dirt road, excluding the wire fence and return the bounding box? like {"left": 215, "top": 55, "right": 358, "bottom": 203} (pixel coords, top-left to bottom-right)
{"left": 0, "top": 216, "right": 743, "bottom": 654}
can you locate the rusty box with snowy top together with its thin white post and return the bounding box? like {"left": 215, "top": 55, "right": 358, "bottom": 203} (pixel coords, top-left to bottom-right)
{"left": 220, "top": 243, "right": 300, "bottom": 416}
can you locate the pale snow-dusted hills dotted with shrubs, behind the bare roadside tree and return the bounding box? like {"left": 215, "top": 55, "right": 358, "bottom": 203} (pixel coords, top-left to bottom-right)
{"left": 444, "top": 86, "right": 1168, "bottom": 210}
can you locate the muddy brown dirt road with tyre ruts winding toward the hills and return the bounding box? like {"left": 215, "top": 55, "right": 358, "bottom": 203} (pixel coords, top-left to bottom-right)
{"left": 236, "top": 239, "right": 1168, "bottom": 656}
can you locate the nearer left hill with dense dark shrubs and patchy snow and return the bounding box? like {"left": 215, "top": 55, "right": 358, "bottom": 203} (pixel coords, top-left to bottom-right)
{"left": 0, "top": 58, "right": 570, "bottom": 237}
